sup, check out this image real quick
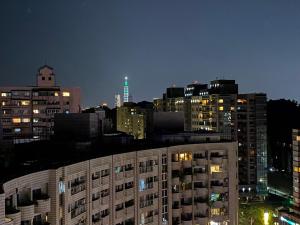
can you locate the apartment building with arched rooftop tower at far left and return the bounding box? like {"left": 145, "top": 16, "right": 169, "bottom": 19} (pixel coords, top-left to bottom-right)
{"left": 0, "top": 65, "right": 80, "bottom": 143}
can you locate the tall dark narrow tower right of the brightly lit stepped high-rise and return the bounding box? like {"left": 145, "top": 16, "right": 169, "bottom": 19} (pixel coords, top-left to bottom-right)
{"left": 236, "top": 94, "right": 267, "bottom": 195}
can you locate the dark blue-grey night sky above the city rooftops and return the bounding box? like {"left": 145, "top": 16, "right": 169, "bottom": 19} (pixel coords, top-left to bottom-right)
{"left": 0, "top": 0, "right": 300, "bottom": 106}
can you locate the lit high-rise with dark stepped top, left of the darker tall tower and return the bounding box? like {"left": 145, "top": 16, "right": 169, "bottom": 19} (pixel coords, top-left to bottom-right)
{"left": 185, "top": 80, "right": 238, "bottom": 140}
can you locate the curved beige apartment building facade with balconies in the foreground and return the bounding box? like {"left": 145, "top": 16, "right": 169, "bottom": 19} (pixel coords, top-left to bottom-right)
{"left": 0, "top": 142, "right": 238, "bottom": 225}
